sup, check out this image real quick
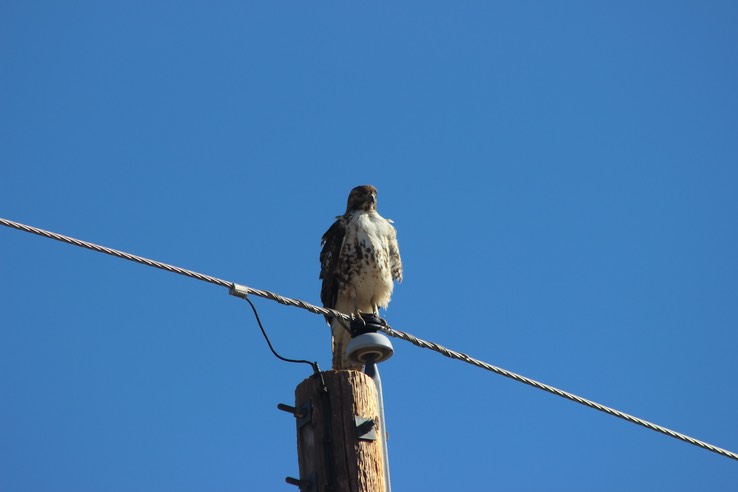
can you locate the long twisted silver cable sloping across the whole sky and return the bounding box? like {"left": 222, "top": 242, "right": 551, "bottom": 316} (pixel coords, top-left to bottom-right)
{"left": 0, "top": 218, "right": 738, "bottom": 461}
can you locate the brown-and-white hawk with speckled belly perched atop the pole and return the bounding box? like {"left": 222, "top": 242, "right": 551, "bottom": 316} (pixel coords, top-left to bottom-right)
{"left": 320, "top": 185, "right": 402, "bottom": 369}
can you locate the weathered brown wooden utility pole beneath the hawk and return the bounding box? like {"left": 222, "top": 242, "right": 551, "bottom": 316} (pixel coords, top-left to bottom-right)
{"left": 280, "top": 371, "right": 386, "bottom": 492}
